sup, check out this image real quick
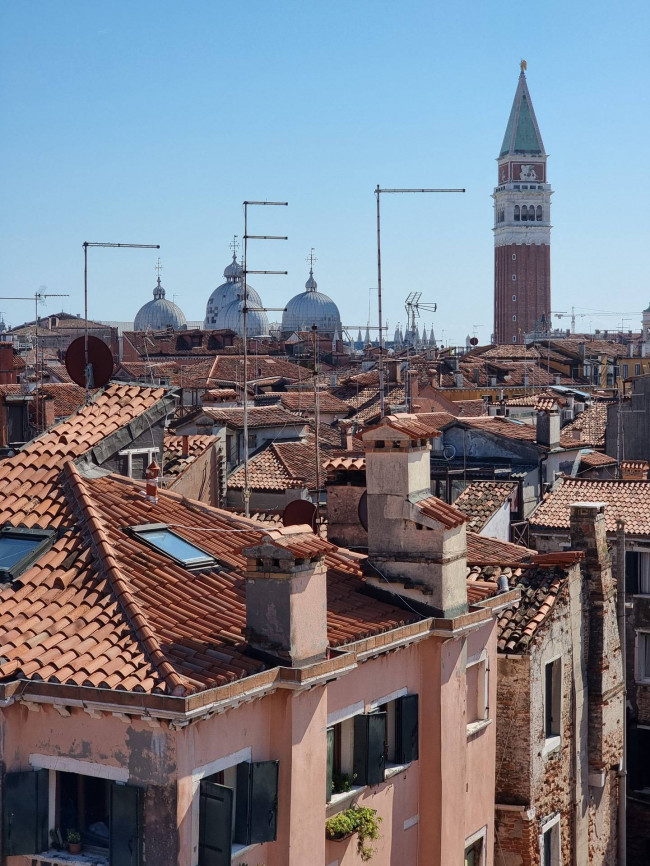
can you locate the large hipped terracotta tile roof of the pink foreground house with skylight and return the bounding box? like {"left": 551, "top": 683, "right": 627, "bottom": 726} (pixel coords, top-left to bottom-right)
{"left": 0, "top": 470, "right": 419, "bottom": 694}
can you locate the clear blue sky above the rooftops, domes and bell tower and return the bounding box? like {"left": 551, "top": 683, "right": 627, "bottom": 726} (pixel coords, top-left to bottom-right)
{"left": 0, "top": 0, "right": 650, "bottom": 342}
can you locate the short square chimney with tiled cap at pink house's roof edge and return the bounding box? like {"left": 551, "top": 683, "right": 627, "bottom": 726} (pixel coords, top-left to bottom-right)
{"left": 243, "top": 526, "right": 330, "bottom": 667}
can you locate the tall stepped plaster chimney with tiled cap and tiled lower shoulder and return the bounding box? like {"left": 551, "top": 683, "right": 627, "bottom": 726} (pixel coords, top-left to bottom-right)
{"left": 363, "top": 415, "right": 467, "bottom": 617}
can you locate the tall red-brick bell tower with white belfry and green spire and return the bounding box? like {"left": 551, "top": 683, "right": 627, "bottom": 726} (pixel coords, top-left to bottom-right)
{"left": 492, "top": 60, "right": 552, "bottom": 344}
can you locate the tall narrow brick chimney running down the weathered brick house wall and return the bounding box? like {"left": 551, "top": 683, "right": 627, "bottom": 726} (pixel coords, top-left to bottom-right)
{"left": 569, "top": 502, "right": 624, "bottom": 776}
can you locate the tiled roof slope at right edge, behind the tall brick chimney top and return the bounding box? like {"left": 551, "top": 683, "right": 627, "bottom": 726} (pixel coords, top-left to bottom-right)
{"left": 530, "top": 478, "right": 650, "bottom": 536}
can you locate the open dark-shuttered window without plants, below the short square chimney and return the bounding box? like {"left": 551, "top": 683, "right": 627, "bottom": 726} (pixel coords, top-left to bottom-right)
{"left": 199, "top": 761, "right": 279, "bottom": 866}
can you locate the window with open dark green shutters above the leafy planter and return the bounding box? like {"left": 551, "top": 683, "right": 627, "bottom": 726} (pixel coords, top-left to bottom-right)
{"left": 344, "top": 695, "right": 418, "bottom": 785}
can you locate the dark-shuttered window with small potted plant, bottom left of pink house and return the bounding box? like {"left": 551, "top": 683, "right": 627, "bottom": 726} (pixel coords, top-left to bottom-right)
{"left": 3, "top": 769, "right": 142, "bottom": 866}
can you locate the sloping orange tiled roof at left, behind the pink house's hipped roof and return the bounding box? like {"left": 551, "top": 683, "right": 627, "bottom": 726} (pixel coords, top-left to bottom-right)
{"left": 0, "top": 385, "right": 165, "bottom": 529}
